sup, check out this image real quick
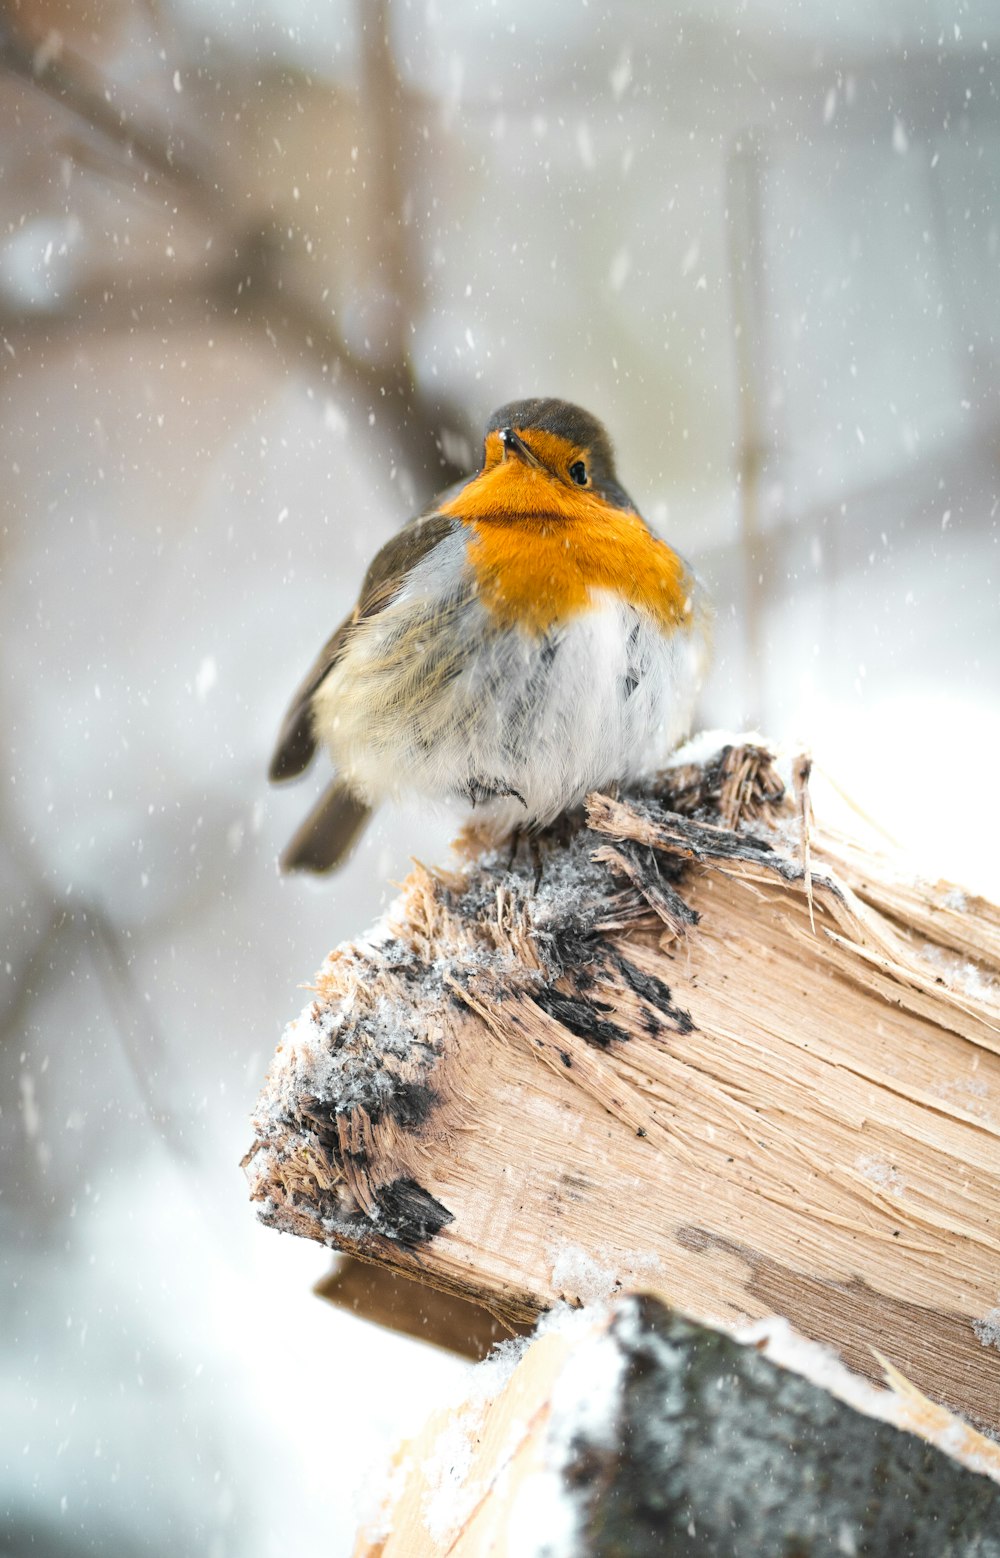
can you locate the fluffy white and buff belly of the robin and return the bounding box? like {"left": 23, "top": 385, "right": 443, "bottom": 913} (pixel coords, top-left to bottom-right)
{"left": 315, "top": 554, "right": 706, "bottom": 827}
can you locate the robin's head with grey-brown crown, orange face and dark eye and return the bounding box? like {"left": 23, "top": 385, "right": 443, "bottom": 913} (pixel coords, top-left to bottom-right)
{"left": 483, "top": 399, "right": 636, "bottom": 509}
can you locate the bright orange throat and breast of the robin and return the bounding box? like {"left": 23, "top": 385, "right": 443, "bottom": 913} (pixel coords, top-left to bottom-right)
{"left": 444, "top": 460, "right": 693, "bottom": 634}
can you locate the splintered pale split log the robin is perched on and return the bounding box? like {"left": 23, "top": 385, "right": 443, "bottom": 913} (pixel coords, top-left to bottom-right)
{"left": 246, "top": 743, "right": 1000, "bottom": 1432}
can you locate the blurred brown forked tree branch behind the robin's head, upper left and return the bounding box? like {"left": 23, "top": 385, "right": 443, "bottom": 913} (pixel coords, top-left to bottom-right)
{"left": 0, "top": 0, "right": 467, "bottom": 497}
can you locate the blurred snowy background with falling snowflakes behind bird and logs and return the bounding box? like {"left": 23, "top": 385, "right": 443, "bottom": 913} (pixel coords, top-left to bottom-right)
{"left": 0, "top": 0, "right": 1000, "bottom": 1558}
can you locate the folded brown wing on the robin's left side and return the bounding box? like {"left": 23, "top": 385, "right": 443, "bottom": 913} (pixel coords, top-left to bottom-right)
{"left": 269, "top": 508, "right": 456, "bottom": 782}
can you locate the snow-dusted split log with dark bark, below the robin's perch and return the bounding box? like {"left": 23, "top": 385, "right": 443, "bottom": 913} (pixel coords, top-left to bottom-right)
{"left": 355, "top": 1298, "right": 1000, "bottom": 1558}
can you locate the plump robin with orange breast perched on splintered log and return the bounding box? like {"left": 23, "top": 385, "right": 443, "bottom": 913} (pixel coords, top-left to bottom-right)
{"left": 269, "top": 397, "right": 712, "bottom": 872}
